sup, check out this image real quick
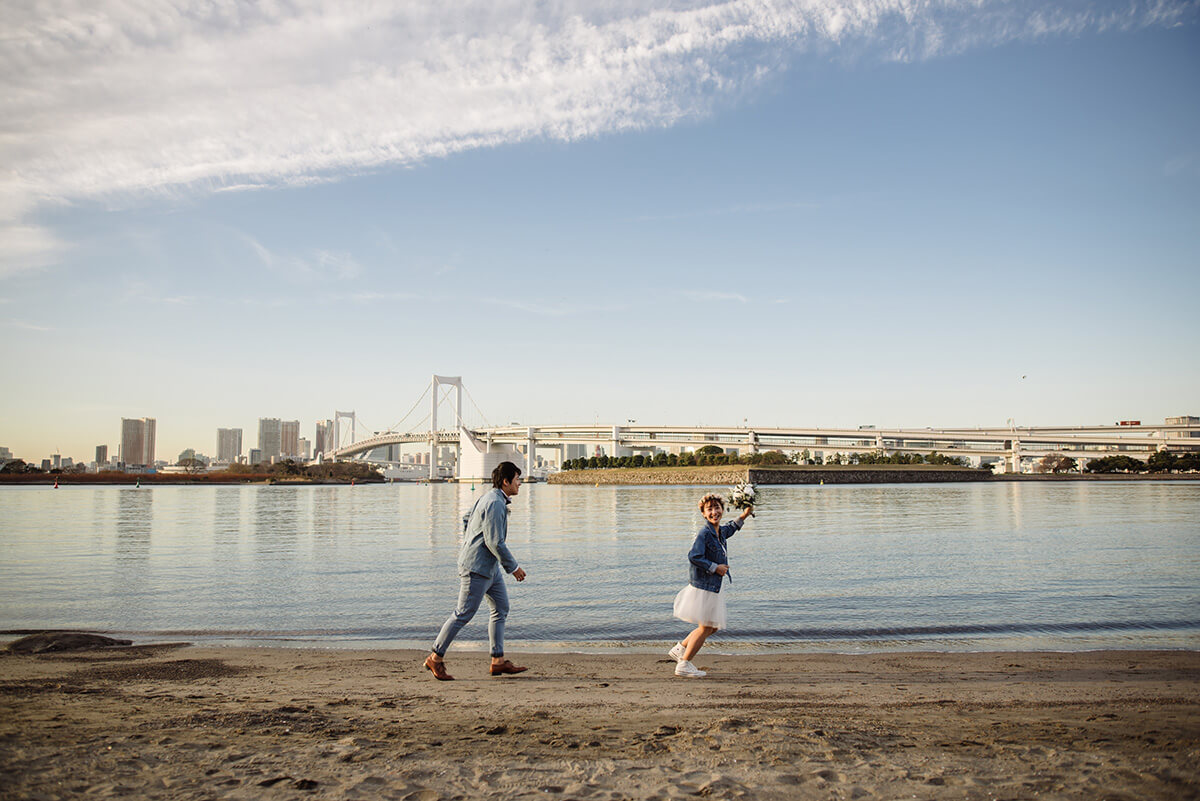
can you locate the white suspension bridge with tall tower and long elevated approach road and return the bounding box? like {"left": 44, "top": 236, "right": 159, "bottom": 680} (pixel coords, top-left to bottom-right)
{"left": 317, "top": 375, "right": 1200, "bottom": 481}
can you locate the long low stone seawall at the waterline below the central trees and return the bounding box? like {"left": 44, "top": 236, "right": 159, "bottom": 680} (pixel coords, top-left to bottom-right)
{"left": 546, "top": 464, "right": 991, "bottom": 486}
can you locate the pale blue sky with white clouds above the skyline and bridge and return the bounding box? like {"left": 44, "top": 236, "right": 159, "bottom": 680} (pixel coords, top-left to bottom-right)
{"left": 0, "top": 0, "right": 1200, "bottom": 459}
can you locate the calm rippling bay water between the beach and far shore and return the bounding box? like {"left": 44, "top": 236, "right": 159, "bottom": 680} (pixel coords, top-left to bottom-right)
{"left": 0, "top": 482, "right": 1200, "bottom": 651}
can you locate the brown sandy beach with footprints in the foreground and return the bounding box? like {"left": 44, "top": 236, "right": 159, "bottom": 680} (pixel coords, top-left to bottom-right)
{"left": 0, "top": 646, "right": 1200, "bottom": 800}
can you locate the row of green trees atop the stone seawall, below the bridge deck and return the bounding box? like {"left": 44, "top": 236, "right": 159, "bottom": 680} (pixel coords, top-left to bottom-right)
{"left": 563, "top": 445, "right": 967, "bottom": 470}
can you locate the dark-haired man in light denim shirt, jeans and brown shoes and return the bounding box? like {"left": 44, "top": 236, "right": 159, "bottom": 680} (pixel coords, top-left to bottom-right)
{"left": 425, "top": 462, "right": 527, "bottom": 681}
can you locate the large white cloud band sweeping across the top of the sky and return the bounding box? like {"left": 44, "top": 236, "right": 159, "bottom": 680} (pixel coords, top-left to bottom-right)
{"left": 0, "top": 0, "right": 1196, "bottom": 276}
